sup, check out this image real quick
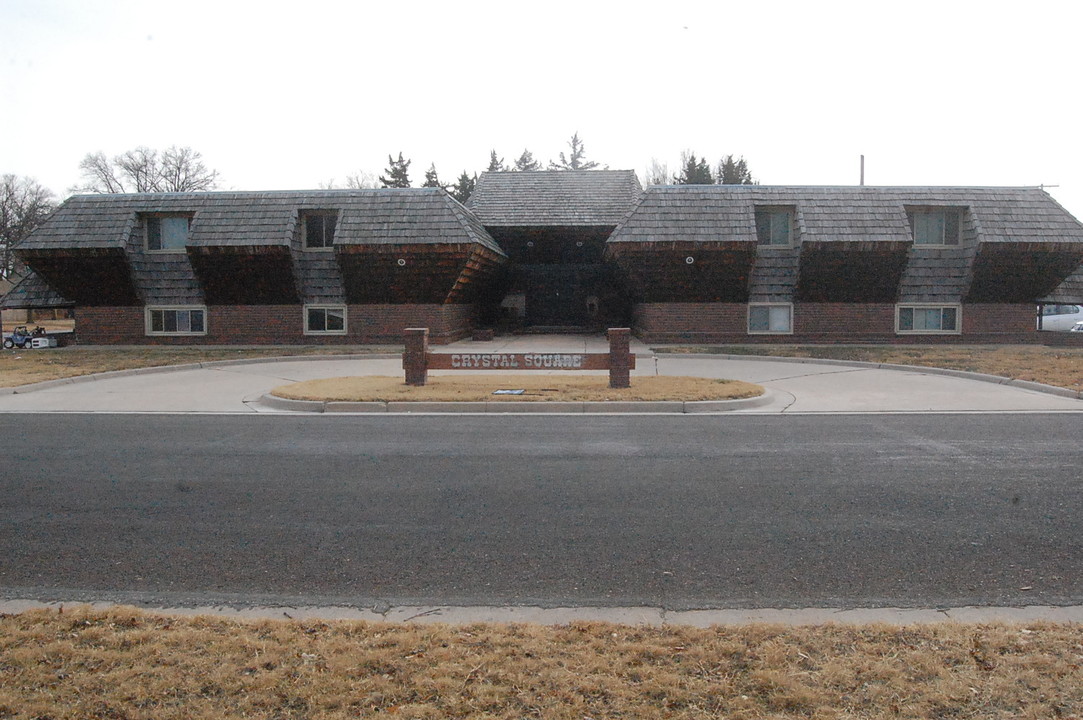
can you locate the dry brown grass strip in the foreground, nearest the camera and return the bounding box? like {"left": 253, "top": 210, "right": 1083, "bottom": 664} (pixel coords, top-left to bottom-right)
{"left": 0, "top": 608, "right": 1083, "bottom": 720}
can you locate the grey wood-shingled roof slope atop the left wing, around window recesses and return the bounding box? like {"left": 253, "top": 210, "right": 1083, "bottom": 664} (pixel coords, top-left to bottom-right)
{"left": 17, "top": 188, "right": 501, "bottom": 252}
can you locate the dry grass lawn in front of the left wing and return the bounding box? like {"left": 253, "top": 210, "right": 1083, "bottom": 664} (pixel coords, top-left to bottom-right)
{"left": 0, "top": 345, "right": 389, "bottom": 388}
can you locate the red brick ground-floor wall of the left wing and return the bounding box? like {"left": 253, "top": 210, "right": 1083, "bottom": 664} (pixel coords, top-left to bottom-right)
{"left": 76, "top": 304, "right": 474, "bottom": 345}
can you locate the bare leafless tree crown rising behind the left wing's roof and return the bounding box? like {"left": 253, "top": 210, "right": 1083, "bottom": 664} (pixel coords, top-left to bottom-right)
{"left": 71, "top": 145, "right": 219, "bottom": 193}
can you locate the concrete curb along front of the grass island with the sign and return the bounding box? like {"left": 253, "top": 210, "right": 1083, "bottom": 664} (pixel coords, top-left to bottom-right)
{"left": 257, "top": 390, "right": 774, "bottom": 415}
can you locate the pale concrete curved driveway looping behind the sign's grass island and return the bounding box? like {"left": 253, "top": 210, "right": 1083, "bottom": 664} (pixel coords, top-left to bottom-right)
{"left": 0, "top": 336, "right": 1083, "bottom": 414}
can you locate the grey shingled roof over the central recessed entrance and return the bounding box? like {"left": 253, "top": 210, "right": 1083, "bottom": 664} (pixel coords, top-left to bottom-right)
{"left": 467, "top": 170, "right": 642, "bottom": 227}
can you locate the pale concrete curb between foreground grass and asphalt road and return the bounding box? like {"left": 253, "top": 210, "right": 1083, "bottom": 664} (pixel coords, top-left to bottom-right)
{"left": 0, "top": 600, "right": 1083, "bottom": 628}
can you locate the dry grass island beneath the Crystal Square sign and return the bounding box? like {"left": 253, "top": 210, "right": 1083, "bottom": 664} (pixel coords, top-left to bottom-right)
{"left": 271, "top": 375, "right": 764, "bottom": 403}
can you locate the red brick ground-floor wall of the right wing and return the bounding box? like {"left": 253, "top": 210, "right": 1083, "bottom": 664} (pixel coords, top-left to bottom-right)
{"left": 634, "top": 296, "right": 1068, "bottom": 344}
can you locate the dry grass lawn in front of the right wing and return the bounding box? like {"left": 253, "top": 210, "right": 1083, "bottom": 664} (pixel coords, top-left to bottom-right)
{"left": 665, "top": 345, "right": 1083, "bottom": 390}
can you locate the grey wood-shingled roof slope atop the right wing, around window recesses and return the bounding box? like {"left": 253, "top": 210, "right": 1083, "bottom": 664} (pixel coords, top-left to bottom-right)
{"left": 609, "top": 185, "right": 1083, "bottom": 243}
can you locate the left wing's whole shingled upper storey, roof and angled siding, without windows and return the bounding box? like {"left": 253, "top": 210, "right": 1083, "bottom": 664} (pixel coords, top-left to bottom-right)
{"left": 9, "top": 188, "right": 505, "bottom": 320}
